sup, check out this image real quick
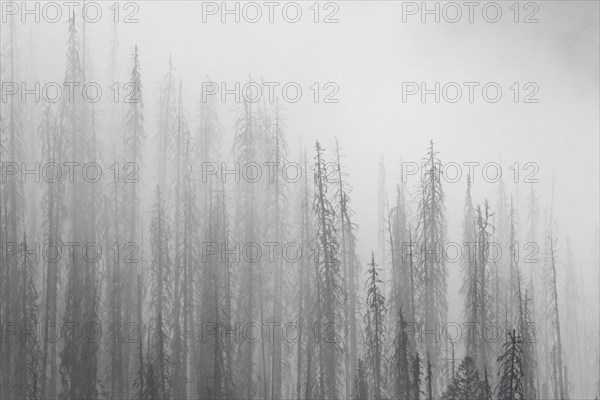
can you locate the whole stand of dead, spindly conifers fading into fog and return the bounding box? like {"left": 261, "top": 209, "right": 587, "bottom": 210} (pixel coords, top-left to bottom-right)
{"left": 0, "top": 14, "right": 599, "bottom": 400}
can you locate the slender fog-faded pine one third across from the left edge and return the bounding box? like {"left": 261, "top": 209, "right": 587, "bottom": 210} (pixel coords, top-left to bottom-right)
{"left": 197, "top": 77, "right": 225, "bottom": 399}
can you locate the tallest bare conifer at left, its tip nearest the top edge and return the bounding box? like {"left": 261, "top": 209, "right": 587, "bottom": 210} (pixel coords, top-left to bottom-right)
{"left": 60, "top": 16, "right": 100, "bottom": 399}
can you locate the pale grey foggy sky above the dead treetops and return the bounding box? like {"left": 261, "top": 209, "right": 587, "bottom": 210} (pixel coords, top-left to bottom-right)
{"left": 5, "top": 1, "right": 600, "bottom": 324}
